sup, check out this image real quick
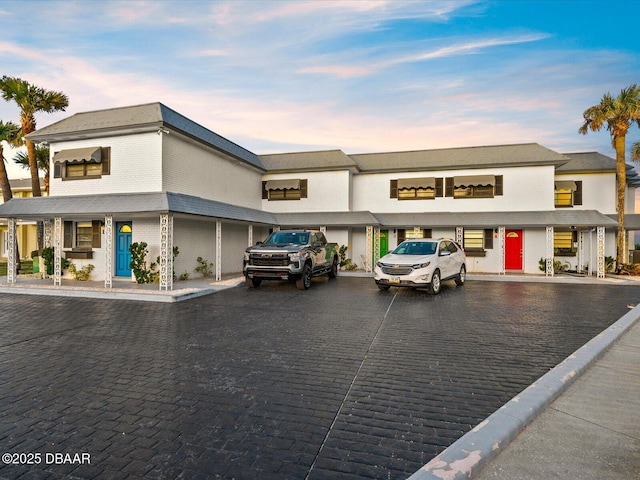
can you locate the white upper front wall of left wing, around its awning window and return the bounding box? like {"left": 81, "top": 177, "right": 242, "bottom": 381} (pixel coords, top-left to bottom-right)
{"left": 49, "top": 133, "right": 162, "bottom": 196}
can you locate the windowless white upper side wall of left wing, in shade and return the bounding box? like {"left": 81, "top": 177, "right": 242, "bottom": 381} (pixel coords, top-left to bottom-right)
{"left": 161, "top": 133, "right": 262, "bottom": 209}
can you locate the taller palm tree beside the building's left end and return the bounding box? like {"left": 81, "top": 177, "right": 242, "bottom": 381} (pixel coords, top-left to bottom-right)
{"left": 0, "top": 75, "right": 69, "bottom": 197}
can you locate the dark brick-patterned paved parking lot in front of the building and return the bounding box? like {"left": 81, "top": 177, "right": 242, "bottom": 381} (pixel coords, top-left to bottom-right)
{"left": 0, "top": 278, "right": 640, "bottom": 479}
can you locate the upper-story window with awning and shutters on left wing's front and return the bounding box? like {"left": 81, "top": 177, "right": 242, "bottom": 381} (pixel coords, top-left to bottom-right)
{"left": 53, "top": 147, "right": 111, "bottom": 180}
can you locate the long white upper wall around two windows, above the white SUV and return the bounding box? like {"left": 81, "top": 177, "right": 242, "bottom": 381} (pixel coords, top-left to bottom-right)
{"left": 353, "top": 166, "right": 554, "bottom": 213}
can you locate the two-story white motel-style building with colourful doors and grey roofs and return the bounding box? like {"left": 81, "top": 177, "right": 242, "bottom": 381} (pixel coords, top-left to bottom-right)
{"left": 0, "top": 103, "right": 636, "bottom": 289}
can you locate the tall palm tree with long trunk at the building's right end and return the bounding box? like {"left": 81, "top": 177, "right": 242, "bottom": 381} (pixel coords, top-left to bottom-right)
{"left": 578, "top": 83, "right": 640, "bottom": 265}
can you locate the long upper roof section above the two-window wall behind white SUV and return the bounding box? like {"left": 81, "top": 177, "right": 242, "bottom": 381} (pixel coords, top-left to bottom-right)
{"left": 349, "top": 143, "right": 569, "bottom": 172}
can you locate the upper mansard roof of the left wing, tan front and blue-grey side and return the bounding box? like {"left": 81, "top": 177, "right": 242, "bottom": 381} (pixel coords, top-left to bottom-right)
{"left": 28, "top": 102, "right": 264, "bottom": 170}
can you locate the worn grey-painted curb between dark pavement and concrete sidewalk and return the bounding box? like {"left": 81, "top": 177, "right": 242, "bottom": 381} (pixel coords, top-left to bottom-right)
{"left": 408, "top": 305, "right": 640, "bottom": 480}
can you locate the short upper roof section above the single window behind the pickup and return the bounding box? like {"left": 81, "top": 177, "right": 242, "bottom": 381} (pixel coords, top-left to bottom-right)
{"left": 260, "top": 150, "right": 356, "bottom": 172}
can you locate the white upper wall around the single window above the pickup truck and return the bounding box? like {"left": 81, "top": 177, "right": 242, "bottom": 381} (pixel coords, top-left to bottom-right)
{"left": 261, "top": 170, "right": 350, "bottom": 213}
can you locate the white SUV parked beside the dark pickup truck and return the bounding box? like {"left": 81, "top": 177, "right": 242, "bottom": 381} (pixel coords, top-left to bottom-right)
{"left": 374, "top": 238, "right": 467, "bottom": 294}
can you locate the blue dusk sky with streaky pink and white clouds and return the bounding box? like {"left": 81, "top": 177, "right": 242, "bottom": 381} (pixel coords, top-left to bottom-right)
{"left": 0, "top": 0, "right": 640, "bottom": 178}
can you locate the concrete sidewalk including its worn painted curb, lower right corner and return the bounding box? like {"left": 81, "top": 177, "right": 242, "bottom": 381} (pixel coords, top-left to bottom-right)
{"left": 410, "top": 300, "right": 640, "bottom": 480}
